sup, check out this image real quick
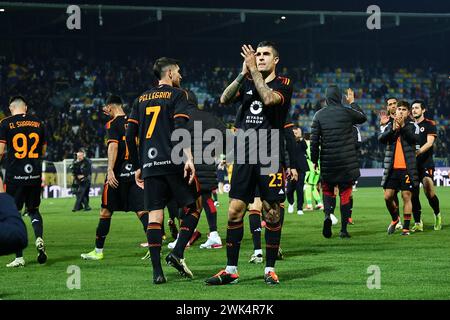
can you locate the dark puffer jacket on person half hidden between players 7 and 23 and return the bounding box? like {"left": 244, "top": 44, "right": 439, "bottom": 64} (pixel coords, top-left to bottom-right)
{"left": 187, "top": 91, "right": 226, "bottom": 191}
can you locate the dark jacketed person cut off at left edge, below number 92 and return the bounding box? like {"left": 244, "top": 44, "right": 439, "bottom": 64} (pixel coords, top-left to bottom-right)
{"left": 0, "top": 177, "right": 28, "bottom": 256}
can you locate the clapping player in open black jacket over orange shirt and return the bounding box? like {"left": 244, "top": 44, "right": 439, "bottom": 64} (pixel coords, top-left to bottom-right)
{"left": 378, "top": 101, "right": 419, "bottom": 235}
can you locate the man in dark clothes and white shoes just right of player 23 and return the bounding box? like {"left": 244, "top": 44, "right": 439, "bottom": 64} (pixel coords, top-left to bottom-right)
{"left": 286, "top": 127, "right": 309, "bottom": 215}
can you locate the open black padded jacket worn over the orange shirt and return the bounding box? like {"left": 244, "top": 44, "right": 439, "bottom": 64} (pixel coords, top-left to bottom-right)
{"left": 378, "top": 121, "right": 419, "bottom": 188}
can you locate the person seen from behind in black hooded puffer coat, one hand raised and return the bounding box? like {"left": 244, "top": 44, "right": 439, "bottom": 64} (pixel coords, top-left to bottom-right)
{"left": 311, "top": 85, "right": 367, "bottom": 238}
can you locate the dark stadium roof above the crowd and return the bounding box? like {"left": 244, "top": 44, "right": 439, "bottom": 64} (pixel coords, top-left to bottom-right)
{"left": 0, "top": 0, "right": 450, "bottom": 64}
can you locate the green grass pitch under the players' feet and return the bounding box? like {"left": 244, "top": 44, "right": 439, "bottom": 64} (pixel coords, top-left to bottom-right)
{"left": 0, "top": 188, "right": 450, "bottom": 300}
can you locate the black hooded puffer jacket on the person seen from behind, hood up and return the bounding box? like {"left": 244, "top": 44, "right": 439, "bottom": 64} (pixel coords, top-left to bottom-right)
{"left": 311, "top": 86, "right": 367, "bottom": 183}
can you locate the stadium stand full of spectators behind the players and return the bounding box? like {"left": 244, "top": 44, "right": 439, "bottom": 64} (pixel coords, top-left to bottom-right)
{"left": 0, "top": 53, "right": 450, "bottom": 168}
